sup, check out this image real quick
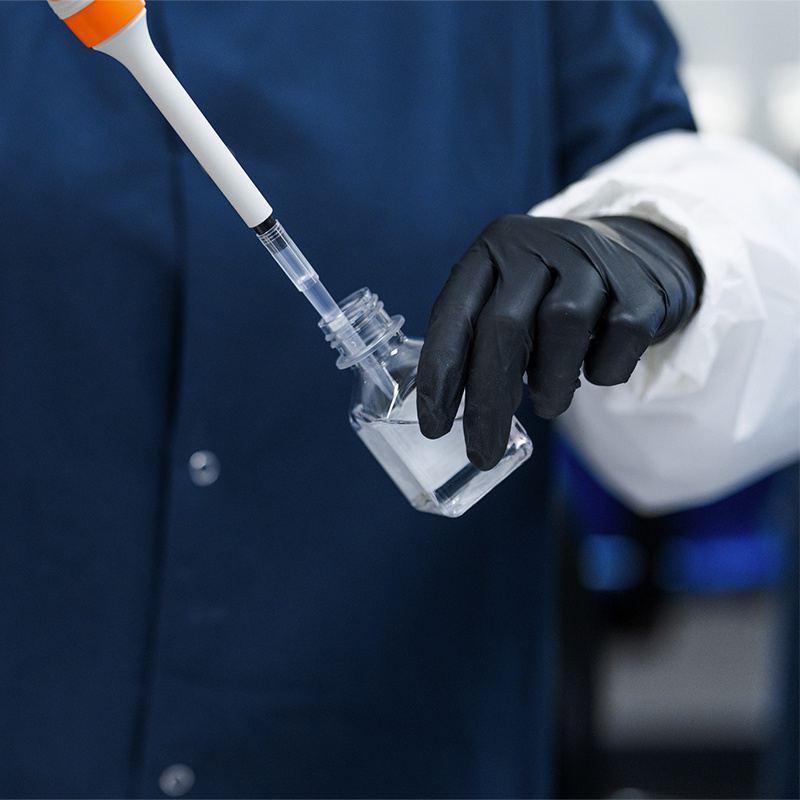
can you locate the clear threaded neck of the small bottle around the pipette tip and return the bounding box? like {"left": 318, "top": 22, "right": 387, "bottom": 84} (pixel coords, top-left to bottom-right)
{"left": 319, "top": 288, "right": 405, "bottom": 369}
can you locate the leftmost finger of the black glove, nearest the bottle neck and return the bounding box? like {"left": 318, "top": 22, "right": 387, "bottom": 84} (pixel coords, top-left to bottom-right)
{"left": 417, "top": 241, "right": 495, "bottom": 438}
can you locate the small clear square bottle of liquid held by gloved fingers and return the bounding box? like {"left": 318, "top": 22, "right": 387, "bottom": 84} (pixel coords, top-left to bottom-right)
{"left": 319, "top": 288, "right": 533, "bottom": 517}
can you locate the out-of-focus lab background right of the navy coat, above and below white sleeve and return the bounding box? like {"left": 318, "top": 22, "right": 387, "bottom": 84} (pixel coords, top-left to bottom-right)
{"left": 560, "top": 0, "right": 800, "bottom": 798}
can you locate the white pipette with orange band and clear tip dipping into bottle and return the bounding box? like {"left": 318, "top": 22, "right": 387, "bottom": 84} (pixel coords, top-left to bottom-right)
{"left": 47, "top": 0, "right": 397, "bottom": 398}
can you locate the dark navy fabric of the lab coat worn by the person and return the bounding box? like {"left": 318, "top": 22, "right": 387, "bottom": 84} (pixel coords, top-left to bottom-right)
{"left": 0, "top": 2, "right": 692, "bottom": 797}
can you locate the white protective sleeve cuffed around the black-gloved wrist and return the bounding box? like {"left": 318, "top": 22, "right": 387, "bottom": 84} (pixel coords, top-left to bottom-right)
{"left": 529, "top": 132, "right": 800, "bottom": 514}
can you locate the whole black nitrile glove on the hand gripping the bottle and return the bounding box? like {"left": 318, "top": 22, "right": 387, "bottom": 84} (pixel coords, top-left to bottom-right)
{"left": 417, "top": 214, "right": 703, "bottom": 469}
